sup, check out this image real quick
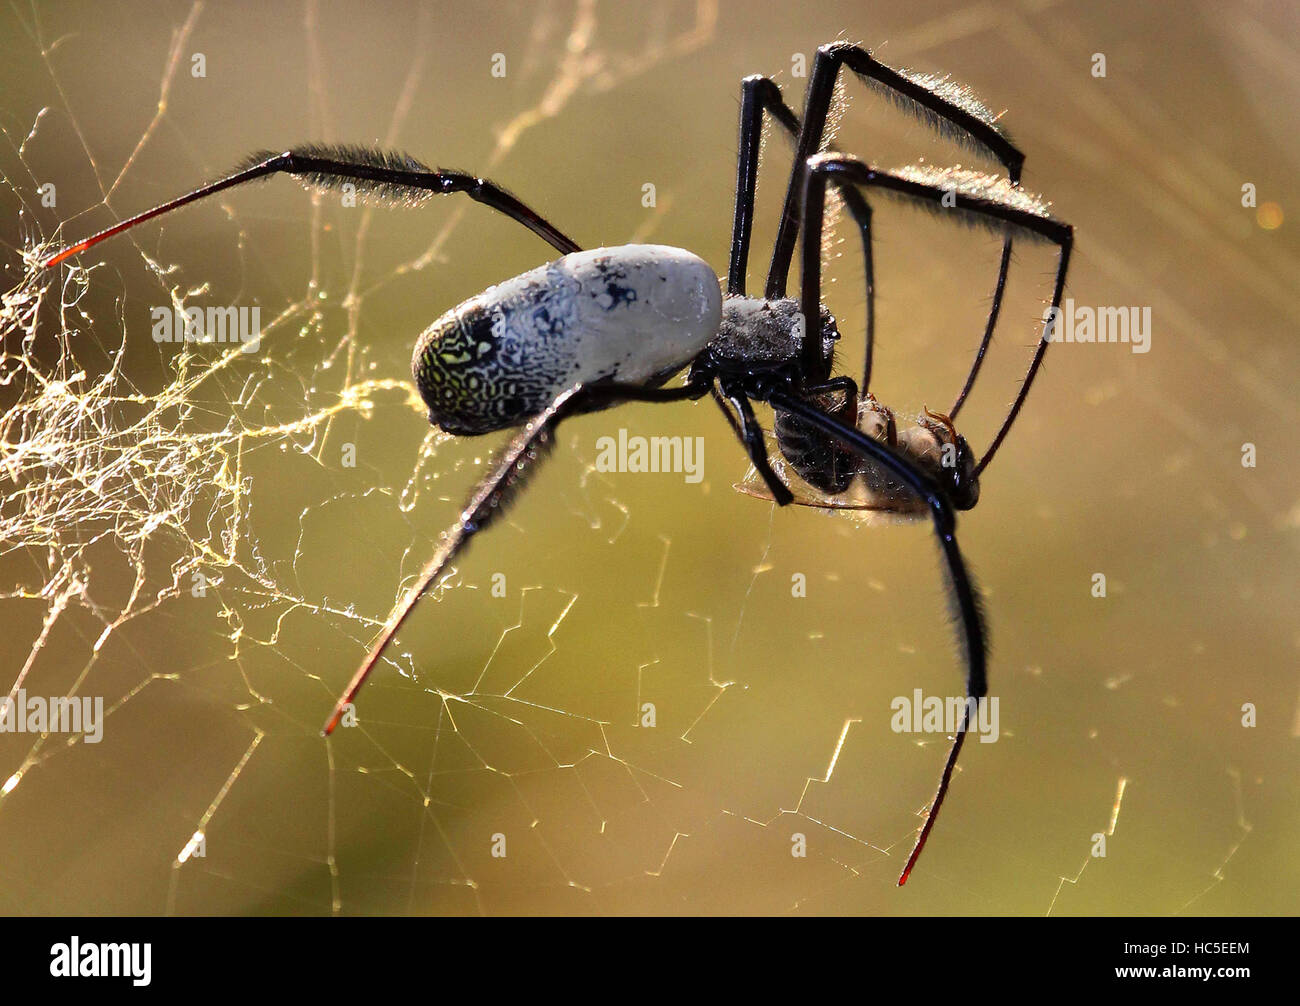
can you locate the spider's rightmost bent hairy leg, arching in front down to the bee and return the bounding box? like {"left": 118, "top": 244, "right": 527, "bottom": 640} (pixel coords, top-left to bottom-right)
{"left": 802, "top": 153, "right": 1074, "bottom": 476}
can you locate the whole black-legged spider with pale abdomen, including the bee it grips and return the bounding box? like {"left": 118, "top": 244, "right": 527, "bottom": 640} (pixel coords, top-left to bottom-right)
{"left": 44, "top": 42, "right": 1073, "bottom": 886}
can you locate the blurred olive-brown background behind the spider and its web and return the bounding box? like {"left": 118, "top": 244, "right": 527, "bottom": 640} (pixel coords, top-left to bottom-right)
{"left": 0, "top": 0, "right": 1300, "bottom": 915}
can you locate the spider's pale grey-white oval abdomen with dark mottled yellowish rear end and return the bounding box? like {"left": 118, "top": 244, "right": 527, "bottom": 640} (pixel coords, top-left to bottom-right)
{"left": 411, "top": 244, "right": 722, "bottom": 434}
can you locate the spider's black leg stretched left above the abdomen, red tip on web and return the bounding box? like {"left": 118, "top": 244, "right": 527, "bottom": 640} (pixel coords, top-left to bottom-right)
{"left": 44, "top": 146, "right": 580, "bottom": 269}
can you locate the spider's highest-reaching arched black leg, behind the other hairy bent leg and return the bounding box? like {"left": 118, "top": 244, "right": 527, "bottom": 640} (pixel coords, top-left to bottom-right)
{"left": 767, "top": 42, "right": 1024, "bottom": 405}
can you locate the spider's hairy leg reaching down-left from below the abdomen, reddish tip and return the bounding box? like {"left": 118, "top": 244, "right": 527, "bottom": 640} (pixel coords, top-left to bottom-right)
{"left": 324, "top": 382, "right": 709, "bottom": 736}
